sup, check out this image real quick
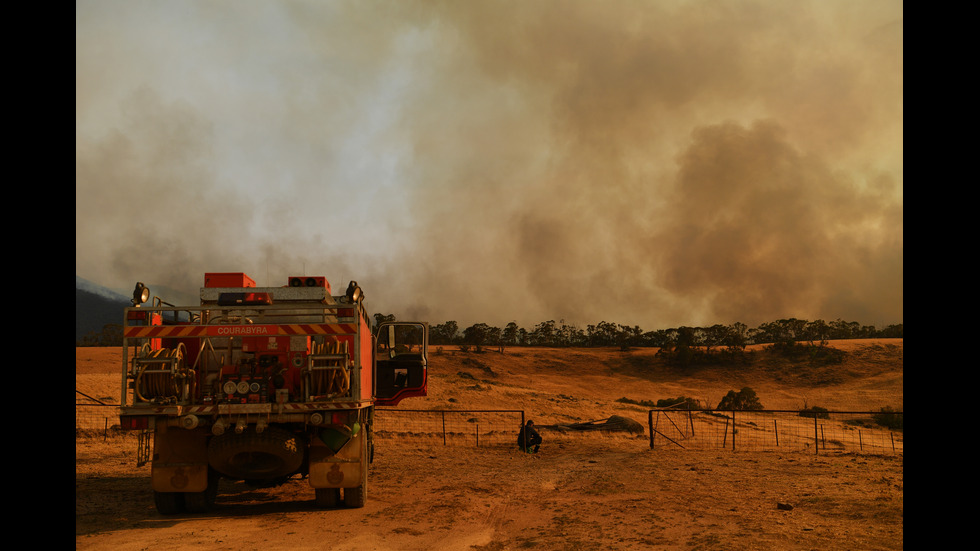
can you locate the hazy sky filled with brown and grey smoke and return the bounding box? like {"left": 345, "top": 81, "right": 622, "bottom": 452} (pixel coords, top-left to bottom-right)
{"left": 75, "top": 0, "right": 904, "bottom": 330}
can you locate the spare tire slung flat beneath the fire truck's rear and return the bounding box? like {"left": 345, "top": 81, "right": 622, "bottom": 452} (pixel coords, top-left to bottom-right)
{"left": 208, "top": 427, "right": 305, "bottom": 480}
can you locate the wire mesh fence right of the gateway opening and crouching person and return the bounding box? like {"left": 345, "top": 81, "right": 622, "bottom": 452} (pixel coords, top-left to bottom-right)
{"left": 648, "top": 409, "right": 905, "bottom": 453}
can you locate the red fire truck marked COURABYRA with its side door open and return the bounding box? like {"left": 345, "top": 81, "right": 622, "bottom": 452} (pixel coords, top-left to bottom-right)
{"left": 120, "top": 273, "right": 428, "bottom": 514}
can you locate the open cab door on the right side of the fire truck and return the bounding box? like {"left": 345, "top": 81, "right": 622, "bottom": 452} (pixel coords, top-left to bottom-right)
{"left": 374, "top": 322, "right": 429, "bottom": 406}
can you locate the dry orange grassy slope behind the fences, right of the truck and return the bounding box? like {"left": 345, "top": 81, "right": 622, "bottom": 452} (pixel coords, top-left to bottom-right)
{"left": 420, "top": 339, "right": 905, "bottom": 416}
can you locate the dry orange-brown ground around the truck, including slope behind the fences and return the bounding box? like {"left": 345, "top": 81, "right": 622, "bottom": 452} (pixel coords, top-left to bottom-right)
{"left": 75, "top": 339, "right": 904, "bottom": 551}
